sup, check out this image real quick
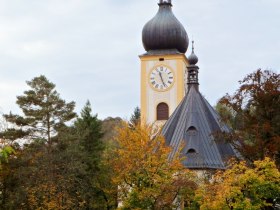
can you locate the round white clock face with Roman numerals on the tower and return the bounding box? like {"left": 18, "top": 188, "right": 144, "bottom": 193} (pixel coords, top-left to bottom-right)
{"left": 150, "top": 66, "right": 174, "bottom": 91}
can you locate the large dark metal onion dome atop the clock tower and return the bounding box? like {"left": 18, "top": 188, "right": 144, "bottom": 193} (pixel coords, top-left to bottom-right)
{"left": 142, "top": 0, "right": 189, "bottom": 53}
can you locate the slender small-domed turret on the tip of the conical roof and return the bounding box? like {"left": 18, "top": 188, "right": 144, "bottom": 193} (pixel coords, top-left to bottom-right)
{"left": 187, "top": 41, "right": 199, "bottom": 90}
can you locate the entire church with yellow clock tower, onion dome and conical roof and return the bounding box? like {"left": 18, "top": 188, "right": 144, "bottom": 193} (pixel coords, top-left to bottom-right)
{"left": 140, "top": 0, "right": 237, "bottom": 170}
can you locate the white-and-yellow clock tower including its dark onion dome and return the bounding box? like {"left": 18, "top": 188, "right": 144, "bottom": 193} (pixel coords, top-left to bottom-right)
{"left": 140, "top": 0, "right": 189, "bottom": 124}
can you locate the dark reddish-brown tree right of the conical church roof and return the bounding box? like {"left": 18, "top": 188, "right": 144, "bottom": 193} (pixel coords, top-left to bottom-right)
{"left": 219, "top": 69, "right": 280, "bottom": 166}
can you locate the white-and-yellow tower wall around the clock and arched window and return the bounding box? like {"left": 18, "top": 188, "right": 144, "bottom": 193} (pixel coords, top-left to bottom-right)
{"left": 140, "top": 54, "right": 188, "bottom": 124}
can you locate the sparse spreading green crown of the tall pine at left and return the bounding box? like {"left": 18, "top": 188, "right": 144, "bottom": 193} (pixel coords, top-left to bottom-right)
{"left": 0, "top": 75, "right": 76, "bottom": 144}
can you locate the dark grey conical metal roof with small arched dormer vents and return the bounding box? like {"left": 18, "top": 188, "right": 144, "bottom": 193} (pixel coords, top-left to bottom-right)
{"left": 162, "top": 85, "right": 237, "bottom": 169}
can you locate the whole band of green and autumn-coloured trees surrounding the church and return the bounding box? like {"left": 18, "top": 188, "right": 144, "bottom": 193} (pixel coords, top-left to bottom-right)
{"left": 0, "top": 70, "right": 280, "bottom": 210}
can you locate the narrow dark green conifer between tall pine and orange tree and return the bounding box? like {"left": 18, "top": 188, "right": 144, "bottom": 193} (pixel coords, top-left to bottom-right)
{"left": 74, "top": 101, "right": 116, "bottom": 209}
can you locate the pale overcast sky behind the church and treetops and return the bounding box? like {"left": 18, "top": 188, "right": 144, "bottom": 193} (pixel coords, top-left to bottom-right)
{"left": 0, "top": 0, "right": 280, "bottom": 119}
